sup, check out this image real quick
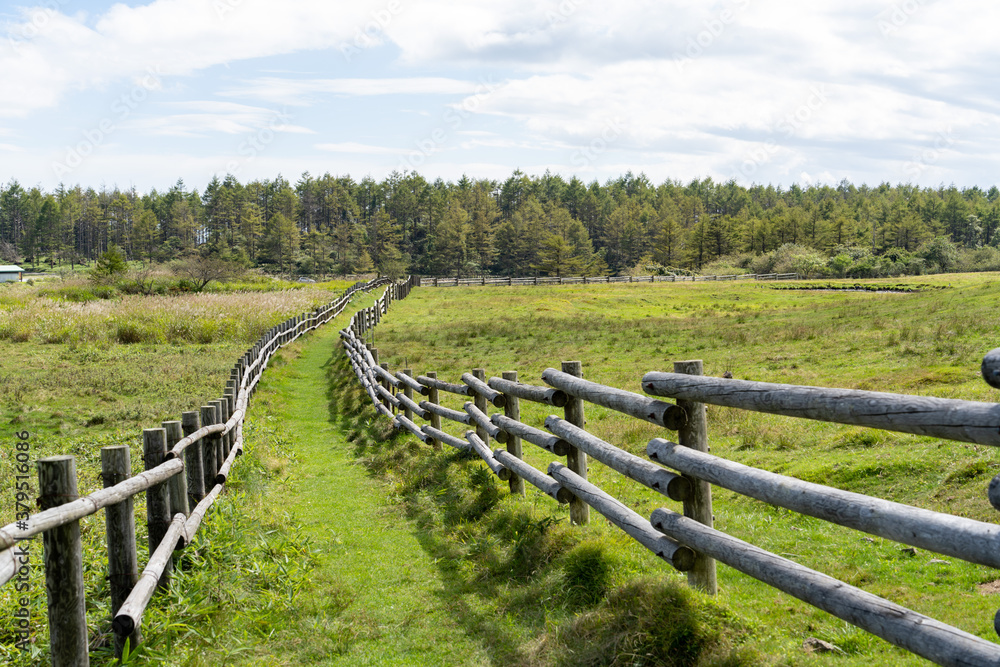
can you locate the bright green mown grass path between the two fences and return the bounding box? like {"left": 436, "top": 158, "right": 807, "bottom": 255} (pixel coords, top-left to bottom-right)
{"left": 252, "top": 326, "right": 490, "bottom": 665}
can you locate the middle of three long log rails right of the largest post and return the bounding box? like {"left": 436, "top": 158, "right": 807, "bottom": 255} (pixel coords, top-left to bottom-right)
{"left": 646, "top": 438, "right": 1000, "bottom": 568}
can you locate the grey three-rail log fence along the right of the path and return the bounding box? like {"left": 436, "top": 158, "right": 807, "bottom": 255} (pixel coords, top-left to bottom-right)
{"left": 340, "top": 279, "right": 1000, "bottom": 667}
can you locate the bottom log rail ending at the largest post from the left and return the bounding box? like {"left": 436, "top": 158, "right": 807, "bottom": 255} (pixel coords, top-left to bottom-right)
{"left": 549, "top": 468, "right": 694, "bottom": 572}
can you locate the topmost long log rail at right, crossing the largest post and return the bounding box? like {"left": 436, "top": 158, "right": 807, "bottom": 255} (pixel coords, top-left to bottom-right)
{"left": 642, "top": 372, "right": 1000, "bottom": 447}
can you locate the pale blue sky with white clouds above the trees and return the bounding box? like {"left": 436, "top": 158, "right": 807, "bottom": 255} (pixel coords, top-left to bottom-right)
{"left": 0, "top": 0, "right": 1000, "bottom": 190}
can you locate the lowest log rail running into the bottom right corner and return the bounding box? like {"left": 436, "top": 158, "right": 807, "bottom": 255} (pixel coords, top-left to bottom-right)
{"left": 651, "top": 508, "right": 1000, "bottom": 667}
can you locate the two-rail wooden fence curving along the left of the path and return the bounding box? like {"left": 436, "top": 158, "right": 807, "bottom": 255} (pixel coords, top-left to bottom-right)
{"left": 0, "top": 279, "right": 388, "bottom": 667}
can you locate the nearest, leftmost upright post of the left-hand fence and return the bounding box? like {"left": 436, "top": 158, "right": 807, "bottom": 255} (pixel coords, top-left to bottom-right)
{"left": 37, "top": 456, "right": 90, "bottom": 667}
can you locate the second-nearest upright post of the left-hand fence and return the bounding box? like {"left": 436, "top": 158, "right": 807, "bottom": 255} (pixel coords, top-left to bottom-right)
{"left": 101, "top": 446, "right": 141, "bottom": 659}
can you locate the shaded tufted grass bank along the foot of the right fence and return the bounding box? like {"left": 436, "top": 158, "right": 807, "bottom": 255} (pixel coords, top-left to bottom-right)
{"left": 327, "top": 354, "right": 753, "bottom": 667}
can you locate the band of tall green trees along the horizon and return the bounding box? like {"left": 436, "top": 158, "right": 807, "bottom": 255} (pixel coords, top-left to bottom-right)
{"left": 0, "top": 170, "right": 1000, "bottom": 276}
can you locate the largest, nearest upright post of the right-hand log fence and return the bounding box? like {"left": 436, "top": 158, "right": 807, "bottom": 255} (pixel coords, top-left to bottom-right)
{"left": 674, "top": 359, "right": 719, "bottom": 595}
